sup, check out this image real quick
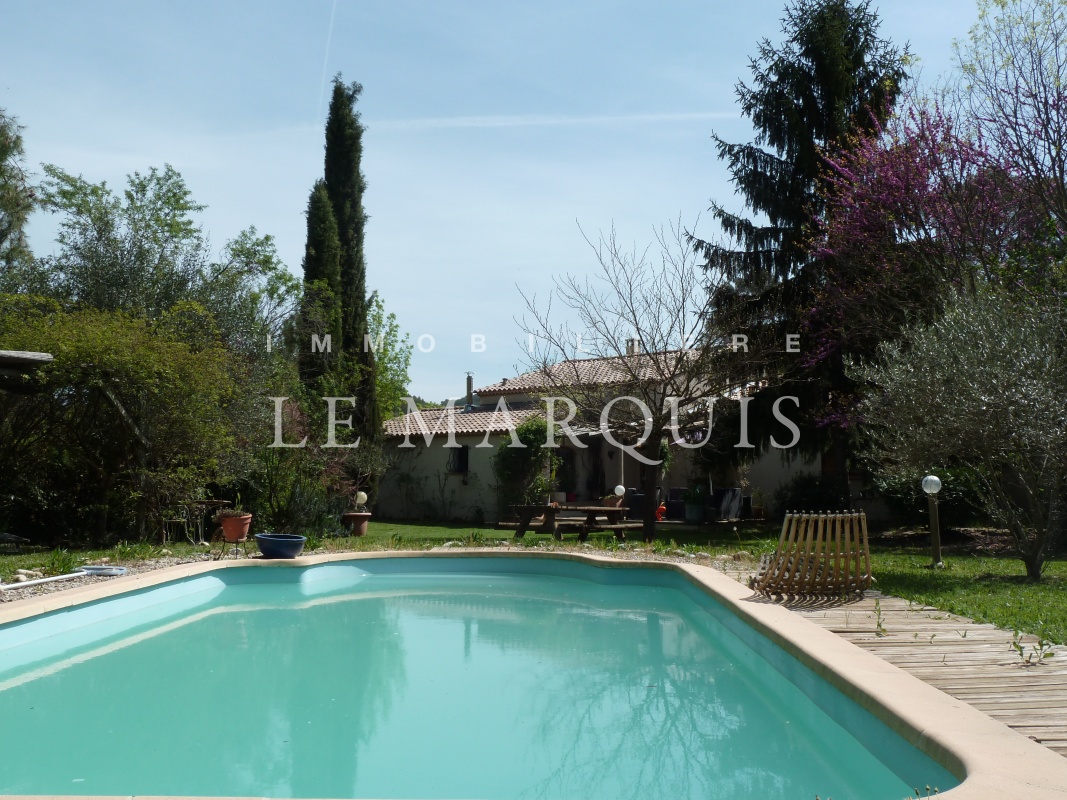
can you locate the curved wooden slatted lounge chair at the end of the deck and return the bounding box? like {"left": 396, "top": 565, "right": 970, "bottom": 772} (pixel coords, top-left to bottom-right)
{"left": 748, "top": 511, "right": 871, "bottom": 597}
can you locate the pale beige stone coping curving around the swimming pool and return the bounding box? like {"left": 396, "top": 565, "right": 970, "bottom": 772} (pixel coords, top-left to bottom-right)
{"left": 0, "top": 549, "right": 1067, "bottom": 800}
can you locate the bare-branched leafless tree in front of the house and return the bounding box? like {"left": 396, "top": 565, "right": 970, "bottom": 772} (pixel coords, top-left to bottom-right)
{"left": 519, "top": 220, "right": 769, "bottom": 541}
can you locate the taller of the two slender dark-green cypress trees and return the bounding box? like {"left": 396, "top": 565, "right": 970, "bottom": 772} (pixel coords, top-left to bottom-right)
{"left": 324, "top": 75, "right": 381, "bottom": 448}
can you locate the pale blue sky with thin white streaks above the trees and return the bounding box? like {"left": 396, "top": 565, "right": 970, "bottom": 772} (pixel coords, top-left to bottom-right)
{"left": 0, "top": 0, "right": 977, "bottom": 400}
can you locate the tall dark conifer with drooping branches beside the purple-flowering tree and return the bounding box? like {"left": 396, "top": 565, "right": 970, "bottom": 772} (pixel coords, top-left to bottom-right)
{"left": 692, "top": 0, "right": 909, "bottom": 497}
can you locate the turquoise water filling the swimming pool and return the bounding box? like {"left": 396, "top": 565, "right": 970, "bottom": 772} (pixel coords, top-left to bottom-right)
{"left": 0, "top": 558, "right": 958, "bottom": 800}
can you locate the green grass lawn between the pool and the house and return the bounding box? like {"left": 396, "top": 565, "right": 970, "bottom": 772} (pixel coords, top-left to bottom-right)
{"left": 0, "top": 522, "right": 1067, "bottom": 644}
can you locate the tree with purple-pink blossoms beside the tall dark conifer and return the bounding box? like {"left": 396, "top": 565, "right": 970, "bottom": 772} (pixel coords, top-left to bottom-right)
{"left": 805, "top": 101, "right": 1041, "bottom": 375}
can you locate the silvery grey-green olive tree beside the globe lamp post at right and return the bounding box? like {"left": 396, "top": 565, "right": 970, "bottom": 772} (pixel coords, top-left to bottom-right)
{"left": 853, "top": 291, "right": 1067, "bottom": 580}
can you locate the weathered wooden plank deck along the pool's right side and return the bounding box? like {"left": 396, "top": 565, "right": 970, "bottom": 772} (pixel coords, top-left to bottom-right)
{"left": 772, "top": 591, "right": 1067, "bottom": 757}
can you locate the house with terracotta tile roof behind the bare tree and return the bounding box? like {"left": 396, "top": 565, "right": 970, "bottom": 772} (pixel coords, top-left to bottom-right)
{"left": 377, "top": 351, "right": 814, "bottom": 523}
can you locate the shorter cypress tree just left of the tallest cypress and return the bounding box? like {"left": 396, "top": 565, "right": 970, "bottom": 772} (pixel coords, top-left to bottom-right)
{"left": 300, "top": 180, "right": 341, "bottom": 383}
